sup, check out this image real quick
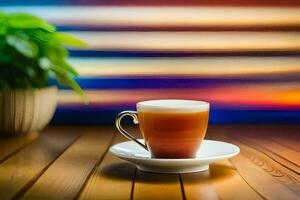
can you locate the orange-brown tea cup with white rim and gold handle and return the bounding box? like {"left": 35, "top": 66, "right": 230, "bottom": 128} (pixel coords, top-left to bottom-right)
{"left": 116, "top": 99, "right": 209, "bottom": 158}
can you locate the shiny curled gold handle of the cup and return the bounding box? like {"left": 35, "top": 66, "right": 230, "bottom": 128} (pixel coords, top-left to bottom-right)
{"left": 115, "top": 111, "right": 148, "bottom": 151}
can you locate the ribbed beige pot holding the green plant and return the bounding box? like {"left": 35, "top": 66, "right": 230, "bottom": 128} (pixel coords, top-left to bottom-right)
{"left": 0, "top": 87, "right": 57, "bottom": 136}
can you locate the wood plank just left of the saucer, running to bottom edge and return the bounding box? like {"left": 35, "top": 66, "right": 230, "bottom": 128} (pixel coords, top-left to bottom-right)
{"left": 23, "top": 127, "right": 114, "bottom": 199}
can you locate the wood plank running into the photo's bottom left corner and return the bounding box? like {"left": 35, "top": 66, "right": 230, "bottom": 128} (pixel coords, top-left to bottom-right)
{"left": 0, "top": 129, "right": 79, "bottom": 199}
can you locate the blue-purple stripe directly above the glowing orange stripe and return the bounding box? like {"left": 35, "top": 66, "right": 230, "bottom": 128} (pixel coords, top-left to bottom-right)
{"left": 49, "top": 77, "right": 300, "bottom": 90}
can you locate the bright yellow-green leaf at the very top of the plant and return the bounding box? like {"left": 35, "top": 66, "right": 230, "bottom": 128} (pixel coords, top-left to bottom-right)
{"left": 8, "top": 13, "right": 55, "bottom": 32}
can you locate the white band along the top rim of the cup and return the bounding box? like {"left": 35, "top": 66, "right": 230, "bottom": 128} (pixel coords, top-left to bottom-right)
{"left": 137, "top": 99, "right": 209, "bottom": 112}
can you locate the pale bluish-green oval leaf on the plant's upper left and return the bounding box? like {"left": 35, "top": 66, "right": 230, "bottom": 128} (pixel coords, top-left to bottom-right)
{"left": 6, "top": 35, "right": 38, "bottom": 58}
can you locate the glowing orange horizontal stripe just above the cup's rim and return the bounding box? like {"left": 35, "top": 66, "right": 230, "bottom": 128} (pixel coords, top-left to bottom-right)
{"left": 59, "top": 81, "right": 300, "bottom": 109}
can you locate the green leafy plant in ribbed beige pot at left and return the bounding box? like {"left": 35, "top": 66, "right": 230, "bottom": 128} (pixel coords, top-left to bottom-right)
{"left": 0, "top": 12, "right": 87, "bottom": 136}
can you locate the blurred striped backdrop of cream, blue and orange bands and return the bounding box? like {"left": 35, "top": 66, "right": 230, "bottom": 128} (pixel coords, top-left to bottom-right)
{"left": 0, "top": 0, "right": 300, "bottom": 124}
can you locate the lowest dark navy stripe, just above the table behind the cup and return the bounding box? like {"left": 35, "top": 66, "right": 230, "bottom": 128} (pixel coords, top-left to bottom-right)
{"left": 51, "top": 106, "right": 300, "bottom": 125}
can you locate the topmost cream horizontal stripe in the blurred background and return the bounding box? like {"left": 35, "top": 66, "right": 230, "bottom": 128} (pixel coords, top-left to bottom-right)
{"left": 2, "top": 6, "right": 300, "bottom": 27}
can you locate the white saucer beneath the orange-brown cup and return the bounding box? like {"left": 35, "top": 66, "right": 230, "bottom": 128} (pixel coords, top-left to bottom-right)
{"left": 109, "top": 139, "right": 240, "bottom": 173}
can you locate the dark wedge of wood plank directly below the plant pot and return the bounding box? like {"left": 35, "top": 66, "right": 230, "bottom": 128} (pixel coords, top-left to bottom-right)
{"left": 0, "top": 132, "right": 38, "bottom": 163}
